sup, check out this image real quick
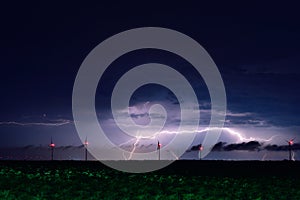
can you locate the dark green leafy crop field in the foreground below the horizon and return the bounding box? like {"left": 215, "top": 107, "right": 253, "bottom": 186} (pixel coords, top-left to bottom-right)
{"left": 0, "top": 161, "right": 300, "bottom": 200}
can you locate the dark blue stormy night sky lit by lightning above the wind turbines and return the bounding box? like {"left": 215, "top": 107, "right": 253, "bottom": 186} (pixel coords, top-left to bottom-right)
{"left": 0, "top": 2, "right": 300, "bottom": 160}
